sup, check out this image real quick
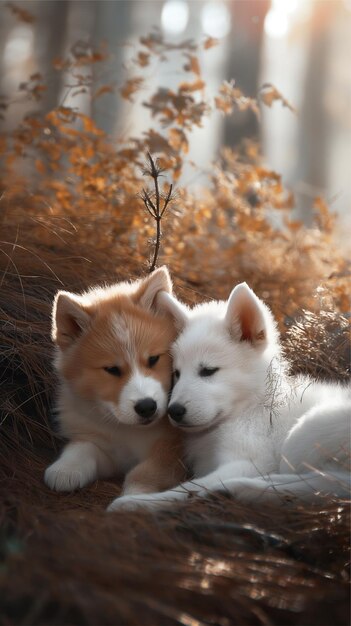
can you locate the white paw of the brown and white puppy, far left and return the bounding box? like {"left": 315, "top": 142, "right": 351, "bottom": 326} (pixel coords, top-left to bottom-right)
{"left": 44, "top": 459, "right": 96, "bottom": 491}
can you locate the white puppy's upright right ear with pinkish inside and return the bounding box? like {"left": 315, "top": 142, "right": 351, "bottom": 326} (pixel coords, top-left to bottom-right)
{"left": 225, "top": 283, "right": 275, "bottom": 348}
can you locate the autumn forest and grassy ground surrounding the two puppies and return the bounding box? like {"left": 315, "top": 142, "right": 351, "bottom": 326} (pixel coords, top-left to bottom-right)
{"left": 0, "top": 0, "right": 351, "bottom": 626}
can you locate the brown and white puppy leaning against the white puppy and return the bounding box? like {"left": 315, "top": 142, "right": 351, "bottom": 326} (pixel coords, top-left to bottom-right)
{"left": 45, "top": 267, "right": 184, "bottom": 494}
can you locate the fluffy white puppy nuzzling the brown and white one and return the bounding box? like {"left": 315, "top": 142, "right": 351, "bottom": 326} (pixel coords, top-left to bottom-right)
{"left": 108, "top": 283, "right": 351, "bottom": 510}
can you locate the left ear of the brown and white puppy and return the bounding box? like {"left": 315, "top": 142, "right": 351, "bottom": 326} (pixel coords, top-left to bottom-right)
{"left": 51, "top": 291, "right": 91, "bottom": 350}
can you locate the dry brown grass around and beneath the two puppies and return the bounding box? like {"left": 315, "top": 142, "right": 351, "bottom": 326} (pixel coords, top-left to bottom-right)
{"left": 0, "top": 215, "right": 349, "bottom": 626}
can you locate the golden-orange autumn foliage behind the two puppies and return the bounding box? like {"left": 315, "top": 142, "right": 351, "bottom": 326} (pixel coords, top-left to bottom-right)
{"left": 0, "top": 31, "right": 348, "bottom": 321}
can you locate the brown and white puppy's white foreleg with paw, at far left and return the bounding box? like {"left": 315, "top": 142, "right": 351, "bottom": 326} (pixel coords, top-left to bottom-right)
{"left": 44, "top": 441, "right": 114, "bottom": 491}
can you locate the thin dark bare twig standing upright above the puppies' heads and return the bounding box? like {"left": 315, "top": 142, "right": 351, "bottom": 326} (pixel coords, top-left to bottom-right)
{"left": 140, "top": 152, "right": 173, "bottom": 274}
